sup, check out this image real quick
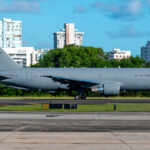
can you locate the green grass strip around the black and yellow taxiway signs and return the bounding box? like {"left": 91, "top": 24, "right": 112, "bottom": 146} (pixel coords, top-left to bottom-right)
{"left": 0, "top": 104, "right": 150, "bottom": 112}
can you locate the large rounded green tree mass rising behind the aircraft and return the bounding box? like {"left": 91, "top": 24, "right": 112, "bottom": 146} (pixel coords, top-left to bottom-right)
{"left": 36, "top": 45, "right": 105, "bottom": 67}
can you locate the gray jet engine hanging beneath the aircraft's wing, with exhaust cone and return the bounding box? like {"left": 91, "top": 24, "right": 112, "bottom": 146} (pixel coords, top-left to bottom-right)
{"left": 92, "top": 83, "right": 120, "bottom": 96}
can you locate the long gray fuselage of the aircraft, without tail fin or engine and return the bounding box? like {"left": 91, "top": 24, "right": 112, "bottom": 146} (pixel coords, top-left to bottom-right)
{"left": 0, "top": 68, "right": 150, "bottom": 91}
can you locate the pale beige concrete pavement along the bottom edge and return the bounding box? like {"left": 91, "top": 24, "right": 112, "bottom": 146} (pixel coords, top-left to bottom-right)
{"left": 0, "top": 132, "right": 150, "bottom": 150}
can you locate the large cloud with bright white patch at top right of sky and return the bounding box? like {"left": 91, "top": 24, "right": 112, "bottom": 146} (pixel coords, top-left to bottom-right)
{"left": 92, "top": 0, "right": 143, "bottom": 20}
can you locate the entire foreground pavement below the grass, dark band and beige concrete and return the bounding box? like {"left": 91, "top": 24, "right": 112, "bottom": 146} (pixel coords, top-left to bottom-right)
{"left": 0, "top": 111, "right": 150, "bottom": 150}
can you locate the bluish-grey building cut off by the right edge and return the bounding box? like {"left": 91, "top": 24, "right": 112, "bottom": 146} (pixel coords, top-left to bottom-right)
{"left": 141, "top": 41, "right": 150, "bottom": 62}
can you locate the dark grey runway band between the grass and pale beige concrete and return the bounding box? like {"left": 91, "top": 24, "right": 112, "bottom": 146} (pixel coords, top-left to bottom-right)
{"left": 0, "top": 112, "right": 150, "bottom": 132}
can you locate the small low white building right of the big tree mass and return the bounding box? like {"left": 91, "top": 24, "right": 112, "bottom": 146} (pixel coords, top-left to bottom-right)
{"left": 108, "top": 48, "right": 131, "bottom": 60}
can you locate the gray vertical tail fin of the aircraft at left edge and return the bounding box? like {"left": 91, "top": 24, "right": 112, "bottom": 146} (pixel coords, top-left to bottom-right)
{"left": 0, "top": 48, "right": 20, "bottom": 71}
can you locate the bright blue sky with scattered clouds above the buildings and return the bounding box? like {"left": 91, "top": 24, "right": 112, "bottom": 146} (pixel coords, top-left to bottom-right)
{"left": 0, "top": 0, "right": 150, "bottom": 56}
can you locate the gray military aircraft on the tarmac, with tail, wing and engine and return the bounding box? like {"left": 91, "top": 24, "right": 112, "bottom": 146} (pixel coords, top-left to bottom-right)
{"left": 0, "top": 48, "right": 150, "bottom": 99}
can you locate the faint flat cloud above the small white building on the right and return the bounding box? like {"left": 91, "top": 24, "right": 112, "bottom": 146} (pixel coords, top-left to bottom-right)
{"left": 106, "top": 25, "right": 150, "bottom": 38}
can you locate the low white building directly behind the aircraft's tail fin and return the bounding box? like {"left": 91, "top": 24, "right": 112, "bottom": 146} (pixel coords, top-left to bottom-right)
{"left": 4, "top": 47, "right": 35, "bottom": 67}
